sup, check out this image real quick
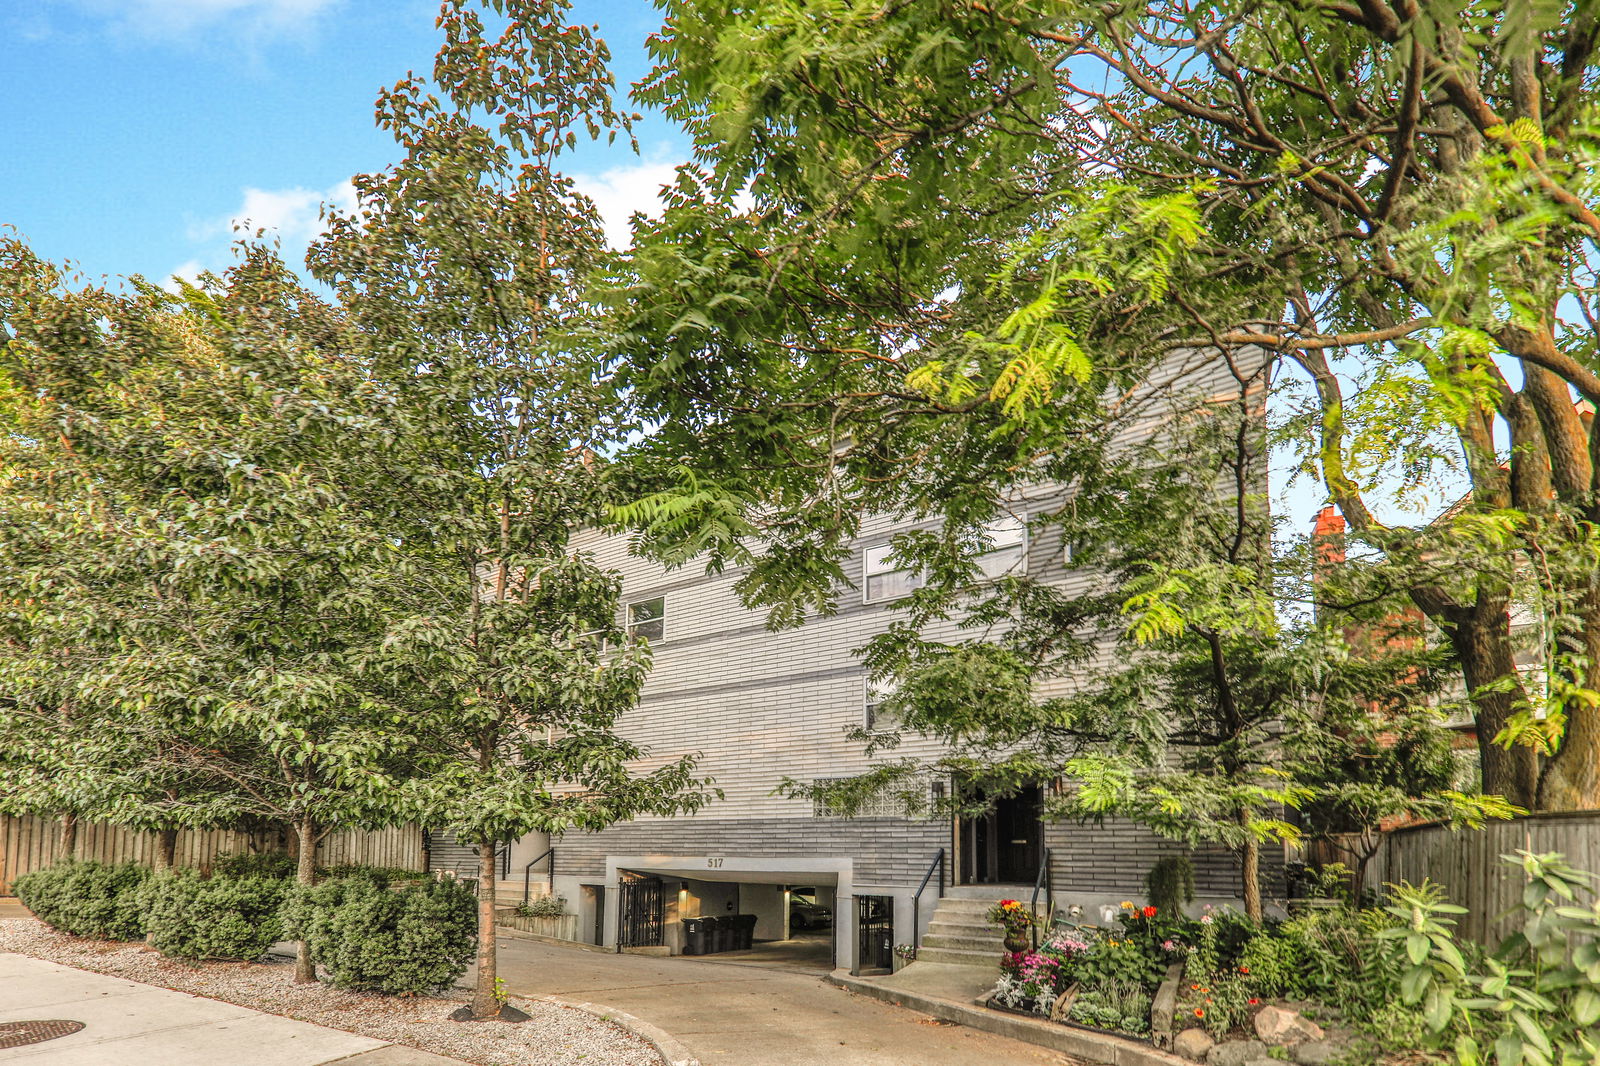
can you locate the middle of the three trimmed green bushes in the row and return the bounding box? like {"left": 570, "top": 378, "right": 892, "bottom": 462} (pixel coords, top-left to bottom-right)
{"left": 139, "top": 871, "right": 288, "bottom": 962}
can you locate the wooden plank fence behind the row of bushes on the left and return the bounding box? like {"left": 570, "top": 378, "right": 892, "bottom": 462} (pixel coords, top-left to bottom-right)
{"left": 0, "top": 816, "right": 427, "bottom": 896}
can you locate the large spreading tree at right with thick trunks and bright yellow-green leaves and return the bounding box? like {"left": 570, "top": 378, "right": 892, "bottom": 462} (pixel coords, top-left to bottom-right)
{"left": 620, "top": 0, "right": 1600, "bottom": 808}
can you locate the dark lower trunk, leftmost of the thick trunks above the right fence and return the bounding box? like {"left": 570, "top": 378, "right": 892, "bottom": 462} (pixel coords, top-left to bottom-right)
{"left": 1450, "top": 610, "right": 1539, "bottom": 810}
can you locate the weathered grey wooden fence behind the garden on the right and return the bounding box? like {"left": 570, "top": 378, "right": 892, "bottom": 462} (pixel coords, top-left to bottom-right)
{"left": 1366, "top": 810, "right": 1600, "bottom": 944}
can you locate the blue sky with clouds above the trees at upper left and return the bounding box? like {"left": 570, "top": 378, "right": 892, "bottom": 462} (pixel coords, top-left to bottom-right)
{"left": 0, "top": 0, "right": 688, "bottom": 279}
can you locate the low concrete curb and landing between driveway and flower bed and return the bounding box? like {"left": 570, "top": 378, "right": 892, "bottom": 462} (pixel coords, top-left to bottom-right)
{"left": 827, "top": 952, "right": 1192, "bottom": 1066}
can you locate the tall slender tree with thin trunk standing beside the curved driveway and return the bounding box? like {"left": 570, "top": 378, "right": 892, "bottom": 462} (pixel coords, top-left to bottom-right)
{"left": 309, "top": 0, "right": 707, "bottom": 1020}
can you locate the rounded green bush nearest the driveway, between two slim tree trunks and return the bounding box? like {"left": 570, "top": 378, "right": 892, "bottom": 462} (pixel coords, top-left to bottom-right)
{"left": 283, "top": 877, "right": 478, "bottom": 996}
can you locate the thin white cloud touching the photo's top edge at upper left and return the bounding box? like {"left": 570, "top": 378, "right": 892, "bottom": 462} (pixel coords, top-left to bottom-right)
{"left": 58, "top": 0, "right": 339, "bottom": 48}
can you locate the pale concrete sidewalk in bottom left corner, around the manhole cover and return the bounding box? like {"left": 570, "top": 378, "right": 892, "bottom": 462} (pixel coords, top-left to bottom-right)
{"left": 0, "top": 954, "right": 466, "bottom": 1066}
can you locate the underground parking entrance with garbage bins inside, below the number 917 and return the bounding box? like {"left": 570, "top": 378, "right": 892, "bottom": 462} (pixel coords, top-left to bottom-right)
{"left": 608, "top": 856, "right": 853, "bottom": 973}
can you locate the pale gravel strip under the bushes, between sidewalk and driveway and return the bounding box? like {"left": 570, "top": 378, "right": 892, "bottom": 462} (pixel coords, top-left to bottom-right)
{"left": 0, "top": 919, "right": 661, "bottom": 1066}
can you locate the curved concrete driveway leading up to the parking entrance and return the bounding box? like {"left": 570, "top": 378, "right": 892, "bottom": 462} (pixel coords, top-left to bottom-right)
{"left": 499, "top": 938, "right": 1074, "bottom": 1066}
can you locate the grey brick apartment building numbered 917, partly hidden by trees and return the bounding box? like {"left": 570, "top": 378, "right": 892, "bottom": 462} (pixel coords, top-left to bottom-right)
{"left": 434, "top": 350, "right": 1282, "bottom": 970}
